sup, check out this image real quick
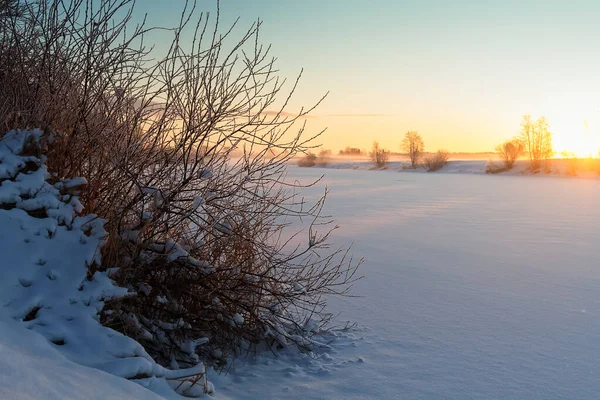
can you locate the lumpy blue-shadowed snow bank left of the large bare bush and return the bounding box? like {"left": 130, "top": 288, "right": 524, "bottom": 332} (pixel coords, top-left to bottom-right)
{"left": 0, "top": 130, "right": 212, "bottom": 398}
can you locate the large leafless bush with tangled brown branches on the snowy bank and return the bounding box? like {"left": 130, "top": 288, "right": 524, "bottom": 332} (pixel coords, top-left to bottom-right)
{"left": 0, "top": 0, "right": 357, "bottom": 367}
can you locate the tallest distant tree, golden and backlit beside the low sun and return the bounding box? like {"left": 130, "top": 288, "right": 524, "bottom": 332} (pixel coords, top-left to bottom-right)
{"left": 521, "top": 115, "right": 554, "bottom": 171}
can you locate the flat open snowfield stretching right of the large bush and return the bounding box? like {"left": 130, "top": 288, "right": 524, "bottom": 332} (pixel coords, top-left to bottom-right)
{"left": 209, "top": 167, "right": 600, "bottom": 400}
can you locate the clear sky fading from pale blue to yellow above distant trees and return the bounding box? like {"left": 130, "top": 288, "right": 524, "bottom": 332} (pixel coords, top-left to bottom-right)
{"left": 137, "top": 0, "right": 600, "bottom": 155}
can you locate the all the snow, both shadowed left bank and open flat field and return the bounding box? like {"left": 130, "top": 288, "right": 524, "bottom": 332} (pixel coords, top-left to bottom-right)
{"left": 0, "top": 131, "right": 600, "bottom": 400}
